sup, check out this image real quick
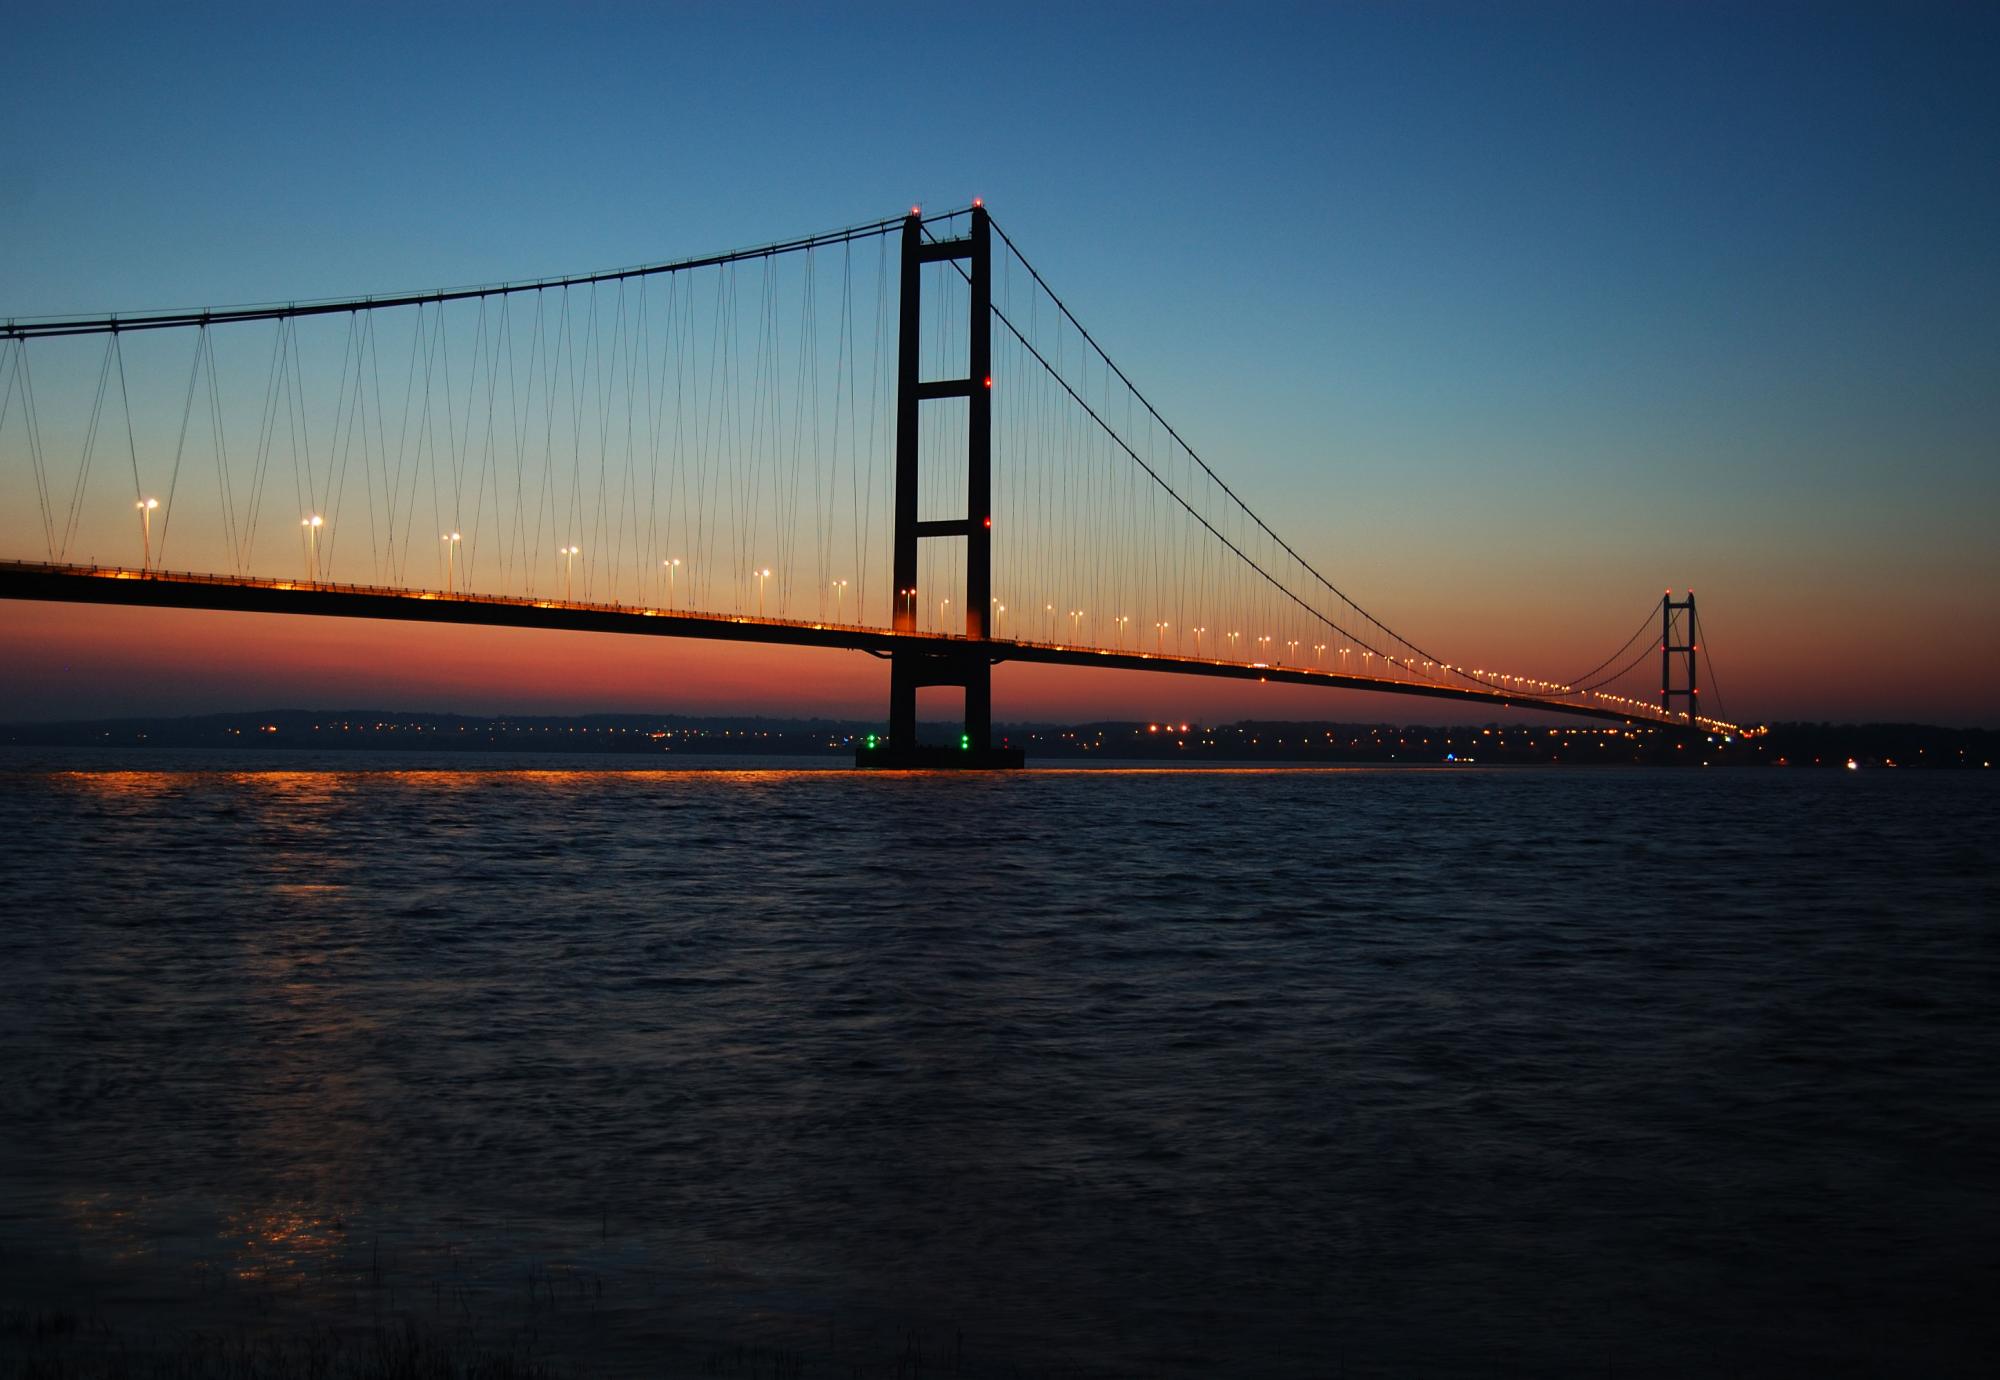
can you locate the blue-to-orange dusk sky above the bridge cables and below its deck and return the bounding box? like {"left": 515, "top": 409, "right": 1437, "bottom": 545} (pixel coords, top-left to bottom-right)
{"left": 0, "top": 4, "right": 2000, "bottom": 724}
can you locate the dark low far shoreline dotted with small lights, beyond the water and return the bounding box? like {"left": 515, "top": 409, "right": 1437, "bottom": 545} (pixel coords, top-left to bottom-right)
{"left": 0, "top": 710, "right": 2000, "bottom": 768}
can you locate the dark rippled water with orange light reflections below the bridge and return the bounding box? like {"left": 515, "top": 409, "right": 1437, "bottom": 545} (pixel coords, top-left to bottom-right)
{"left": 0, "top": 754, "right": 2000, "bottom": 1376}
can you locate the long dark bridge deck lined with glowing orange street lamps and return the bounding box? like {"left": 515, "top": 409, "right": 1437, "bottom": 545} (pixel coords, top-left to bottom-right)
{"left": 0, "top": 560, "right": 1686, "bottom": 728}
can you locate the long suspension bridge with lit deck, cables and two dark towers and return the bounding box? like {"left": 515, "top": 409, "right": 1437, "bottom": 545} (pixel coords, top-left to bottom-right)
{"left": 0, "top": 202, "right": 1742, "bottom": 766}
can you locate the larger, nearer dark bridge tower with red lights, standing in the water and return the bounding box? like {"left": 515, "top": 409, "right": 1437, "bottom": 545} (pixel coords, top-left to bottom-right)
{"left": 854, "top": 206, "right": 1022, "bottom": 768}
